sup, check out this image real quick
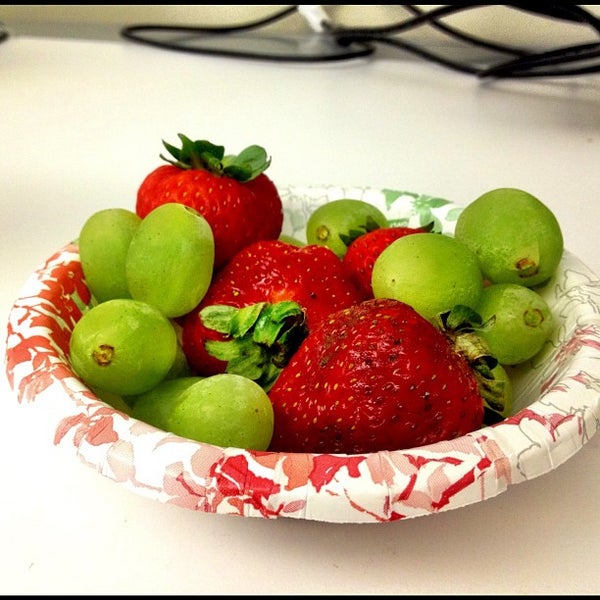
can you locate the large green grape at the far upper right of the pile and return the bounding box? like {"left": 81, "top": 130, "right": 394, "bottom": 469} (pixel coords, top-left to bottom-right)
{"left": 454, "top": 188, "right": 563, "bottom": 287}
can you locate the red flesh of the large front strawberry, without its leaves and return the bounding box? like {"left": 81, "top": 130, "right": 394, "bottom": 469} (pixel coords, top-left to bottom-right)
{"left": 269, "top": 298, "right": 483, "bottom": 454}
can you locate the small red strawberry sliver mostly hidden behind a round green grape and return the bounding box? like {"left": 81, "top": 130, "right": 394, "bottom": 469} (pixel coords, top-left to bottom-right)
{"left": 343, "top": 223, "right": 433, "bottom": 299}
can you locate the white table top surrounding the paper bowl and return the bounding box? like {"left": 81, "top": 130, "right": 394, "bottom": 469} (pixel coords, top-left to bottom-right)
{"left": 0, "top": 37, "right": 600, "bottom": 595}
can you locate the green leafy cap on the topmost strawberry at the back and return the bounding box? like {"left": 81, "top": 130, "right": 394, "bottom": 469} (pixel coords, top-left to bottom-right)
{"left": 160, "top": 133, "right": 271, "bottom": 182}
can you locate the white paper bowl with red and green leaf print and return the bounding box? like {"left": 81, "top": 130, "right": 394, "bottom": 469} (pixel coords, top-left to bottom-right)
{"left": 6, "top": 186, "right": 600, "bottom": 523}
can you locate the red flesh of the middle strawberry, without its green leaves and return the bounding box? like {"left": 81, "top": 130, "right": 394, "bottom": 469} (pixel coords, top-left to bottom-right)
{"left": 182, "top": 240, "right": 360, "bottom": 375}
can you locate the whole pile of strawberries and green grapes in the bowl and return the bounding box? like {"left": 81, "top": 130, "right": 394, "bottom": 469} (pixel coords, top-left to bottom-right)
{"left": 70, "top": 135, "right": 563, "bottom": 454}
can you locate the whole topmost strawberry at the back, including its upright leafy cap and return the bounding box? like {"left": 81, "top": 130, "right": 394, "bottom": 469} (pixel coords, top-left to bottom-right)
{"left": 135, "top": 134, "right": 283, "bottom": 269}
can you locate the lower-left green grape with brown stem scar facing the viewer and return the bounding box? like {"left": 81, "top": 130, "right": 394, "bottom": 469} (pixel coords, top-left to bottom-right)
{"left": 69, "top": 298, "right": 177, "bottom": 396}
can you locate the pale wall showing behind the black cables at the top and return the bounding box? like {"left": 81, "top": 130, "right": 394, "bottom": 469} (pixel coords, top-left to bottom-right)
{"left": 0, "top": 4, "right": 600, "bottom": 49}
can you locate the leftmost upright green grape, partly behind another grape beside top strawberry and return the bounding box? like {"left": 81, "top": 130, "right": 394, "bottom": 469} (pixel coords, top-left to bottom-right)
{"left": 77, "top": 208, "right": 142, "bottom": 302}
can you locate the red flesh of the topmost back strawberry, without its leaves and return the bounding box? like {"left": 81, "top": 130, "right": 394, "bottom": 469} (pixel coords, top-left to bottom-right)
{"left": 135, "top": 164, "right": 283, "bottom": 269}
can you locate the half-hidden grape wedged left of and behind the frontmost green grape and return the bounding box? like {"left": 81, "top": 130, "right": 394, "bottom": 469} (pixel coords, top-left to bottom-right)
{"left": 125, "top": 375, "right": 202, "bottom": 430}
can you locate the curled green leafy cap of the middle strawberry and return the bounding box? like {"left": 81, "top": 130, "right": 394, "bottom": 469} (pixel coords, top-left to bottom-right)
{"left": 199, "top": 301, "right": 308, "bottom": 391}
